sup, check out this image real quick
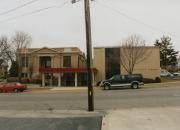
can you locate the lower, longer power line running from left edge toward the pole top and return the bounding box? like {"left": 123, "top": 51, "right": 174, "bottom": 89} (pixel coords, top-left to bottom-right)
{"left": 0, "top": 1, "right": 68, "bottom": 23}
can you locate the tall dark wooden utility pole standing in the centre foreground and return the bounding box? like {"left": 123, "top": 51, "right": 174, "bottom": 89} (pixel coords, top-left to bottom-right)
{"left": 84, "top": 0, "right": 94, "bottom": 111}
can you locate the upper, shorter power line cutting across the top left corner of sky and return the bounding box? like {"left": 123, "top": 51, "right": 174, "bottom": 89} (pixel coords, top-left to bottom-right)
{"left": 0, "top": 0, "right": 39, "bottom": 15}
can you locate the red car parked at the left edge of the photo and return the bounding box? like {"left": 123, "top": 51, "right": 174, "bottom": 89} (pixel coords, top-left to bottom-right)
{"left": 0, "top": 82, "right": 27, "bottom": 92}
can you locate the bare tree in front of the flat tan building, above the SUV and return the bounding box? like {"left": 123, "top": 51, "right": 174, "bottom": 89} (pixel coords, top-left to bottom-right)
{"left": 120, "top": 35, "right": 151, "bottom": 74}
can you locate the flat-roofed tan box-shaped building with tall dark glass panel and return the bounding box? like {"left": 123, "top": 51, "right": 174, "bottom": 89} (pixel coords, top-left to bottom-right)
{"left": 93, "top": 47, "right": 160, "bottom": 81}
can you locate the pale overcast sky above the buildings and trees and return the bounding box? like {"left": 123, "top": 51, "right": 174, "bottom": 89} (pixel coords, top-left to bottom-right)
{"left": 0, "top": 0, "right": 180, "bottom": 51}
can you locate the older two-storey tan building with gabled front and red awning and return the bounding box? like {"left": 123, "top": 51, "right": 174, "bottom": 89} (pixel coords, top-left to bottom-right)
{"left": 17, "top": 47, "right": 96, "bottom": 86}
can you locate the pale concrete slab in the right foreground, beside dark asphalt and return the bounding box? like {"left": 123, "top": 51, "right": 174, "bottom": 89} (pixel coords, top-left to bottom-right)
{"left": 102, "top": 107, "right": 180, "bottom": 130}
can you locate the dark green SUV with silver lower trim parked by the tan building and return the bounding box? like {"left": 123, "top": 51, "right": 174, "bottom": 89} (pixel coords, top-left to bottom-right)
{"left": 100, "top": 74, "right": 144, "bottom": 90}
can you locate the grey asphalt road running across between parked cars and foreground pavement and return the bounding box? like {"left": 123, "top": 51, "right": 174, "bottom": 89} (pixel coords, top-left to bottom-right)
{"left": 0, "top": 86, "right": 180, "bottom": 111}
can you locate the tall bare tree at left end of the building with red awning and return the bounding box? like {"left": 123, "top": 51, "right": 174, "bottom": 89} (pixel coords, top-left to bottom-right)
{"left": 12, "top": 31, "right": 32, "bottom": 82}
